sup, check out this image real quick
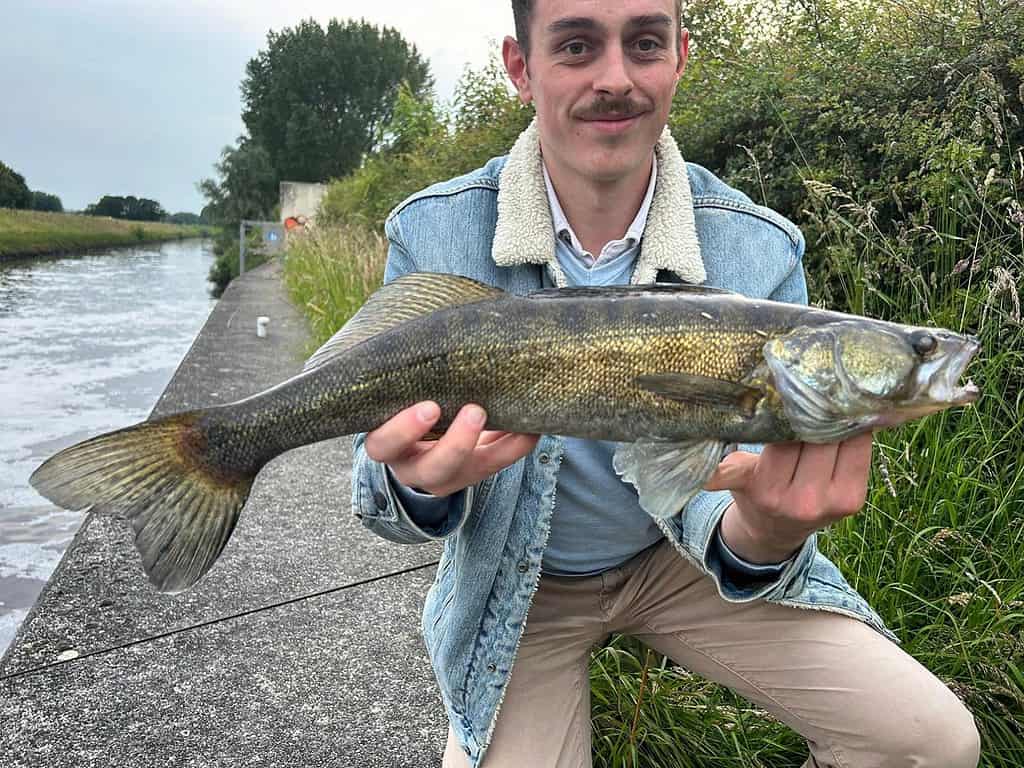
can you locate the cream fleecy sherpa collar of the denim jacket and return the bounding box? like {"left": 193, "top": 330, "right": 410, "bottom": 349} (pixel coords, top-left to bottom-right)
{"left": 492, "top": 119, "right": 707, "bottom": 287}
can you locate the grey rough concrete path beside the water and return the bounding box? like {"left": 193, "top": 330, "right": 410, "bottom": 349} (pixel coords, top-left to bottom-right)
{"left": 0, "top": 263, "right": 445, "bottom": 768}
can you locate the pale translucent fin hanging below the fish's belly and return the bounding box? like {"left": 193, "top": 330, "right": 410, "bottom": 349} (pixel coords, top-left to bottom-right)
{"left": 611, "top": 440, "right": 726, "bottom": 518}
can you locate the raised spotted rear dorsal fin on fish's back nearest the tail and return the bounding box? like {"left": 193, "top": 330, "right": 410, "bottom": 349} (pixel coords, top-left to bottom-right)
{"left": 302, "top": 272, "right": 505, "bottom": 373}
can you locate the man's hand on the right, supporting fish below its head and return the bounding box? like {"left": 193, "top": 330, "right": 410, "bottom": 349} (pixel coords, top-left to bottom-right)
{"left": 705, "top": 432, "right": 872, "bottom": 563}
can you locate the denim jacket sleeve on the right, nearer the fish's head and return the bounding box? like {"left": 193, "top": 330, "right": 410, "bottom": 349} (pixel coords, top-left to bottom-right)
{"left": 680, "top": 225, "right": 817, "bottom": 602}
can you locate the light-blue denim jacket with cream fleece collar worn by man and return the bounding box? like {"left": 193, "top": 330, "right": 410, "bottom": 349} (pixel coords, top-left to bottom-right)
{"left": 352, "top": 123, "right": 896, "bottom": 766}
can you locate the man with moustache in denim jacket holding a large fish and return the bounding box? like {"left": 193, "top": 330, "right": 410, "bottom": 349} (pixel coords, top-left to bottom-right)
{"left": 352, "top": 0, "right": 979, "bottom": 768}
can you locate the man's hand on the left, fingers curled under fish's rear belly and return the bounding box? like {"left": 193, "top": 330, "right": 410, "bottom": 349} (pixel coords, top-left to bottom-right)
{"left": 365, "top": 401, "right": 540, "bottom": 496}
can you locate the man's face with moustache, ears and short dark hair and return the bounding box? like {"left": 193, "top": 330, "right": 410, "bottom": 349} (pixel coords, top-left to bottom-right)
{"left": 504, "top": 0, "right": 688, "bottom": 182}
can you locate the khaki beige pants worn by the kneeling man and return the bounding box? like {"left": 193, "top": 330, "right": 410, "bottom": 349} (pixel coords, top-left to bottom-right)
{"left": 443, "top": 542, "right": 980, "bottom": 768}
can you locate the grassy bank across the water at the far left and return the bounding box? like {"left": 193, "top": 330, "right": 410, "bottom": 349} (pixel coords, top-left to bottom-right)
{"left": 0, "top": 208, "right": 211, "bottom": 257}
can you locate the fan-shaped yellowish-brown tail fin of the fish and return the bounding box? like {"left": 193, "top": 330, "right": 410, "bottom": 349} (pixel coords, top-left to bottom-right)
{"left": 30, "top": 411, "right": 258, "bottom": 593}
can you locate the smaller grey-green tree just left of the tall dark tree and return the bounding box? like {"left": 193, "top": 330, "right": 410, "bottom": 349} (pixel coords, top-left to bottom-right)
{"left": 193, "top": 136, "right": 279, "bottom": 229}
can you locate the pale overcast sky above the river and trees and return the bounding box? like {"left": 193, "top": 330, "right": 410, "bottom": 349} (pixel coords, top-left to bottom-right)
{"left": 0, "top": 0, "right": 512, "bottom": 213}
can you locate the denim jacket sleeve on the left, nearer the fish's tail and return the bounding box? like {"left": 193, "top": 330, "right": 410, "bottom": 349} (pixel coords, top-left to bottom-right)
{"left": 352, "top": 218, "right": 473, "bottom": 544}
